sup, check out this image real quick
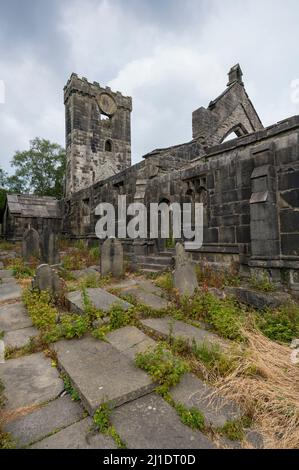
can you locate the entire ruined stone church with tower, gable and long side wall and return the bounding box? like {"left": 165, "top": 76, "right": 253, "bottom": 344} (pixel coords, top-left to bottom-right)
{"left": 4, "top": 64, "right": 299, "bottom": 289}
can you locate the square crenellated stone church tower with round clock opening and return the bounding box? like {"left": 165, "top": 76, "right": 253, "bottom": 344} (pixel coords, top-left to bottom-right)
{"left": 64, "top": 73, "right": 132, "bottom": 196}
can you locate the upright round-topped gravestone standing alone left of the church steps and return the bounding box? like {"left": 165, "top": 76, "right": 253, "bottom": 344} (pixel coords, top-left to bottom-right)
{"left": 101, "top": 238, "right": 124, "bottom": 277}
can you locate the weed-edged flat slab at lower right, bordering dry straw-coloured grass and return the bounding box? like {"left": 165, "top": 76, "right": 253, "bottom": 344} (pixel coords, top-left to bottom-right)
{"left": 170, "top": 373, "right": 242, "bottom": 427}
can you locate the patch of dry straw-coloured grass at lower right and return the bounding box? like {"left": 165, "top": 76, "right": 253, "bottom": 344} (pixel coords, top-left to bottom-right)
{"left": 216, "top": 331, "right": 299, "bottom": 449}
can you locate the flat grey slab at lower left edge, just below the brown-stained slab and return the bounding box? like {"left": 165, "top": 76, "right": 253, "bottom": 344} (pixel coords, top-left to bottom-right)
{"left": 3, "top": 395, "right": 84, "bottom": 448}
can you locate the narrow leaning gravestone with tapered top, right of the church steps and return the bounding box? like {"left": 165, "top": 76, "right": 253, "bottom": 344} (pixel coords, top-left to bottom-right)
{"left": 174, "top": 243, "right": 198, "bottom": 295}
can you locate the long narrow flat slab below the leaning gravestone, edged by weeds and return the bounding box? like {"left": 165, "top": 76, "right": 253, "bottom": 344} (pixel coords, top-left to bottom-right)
{"left": 141, "top": 317, "right": 228, "bottom": 349}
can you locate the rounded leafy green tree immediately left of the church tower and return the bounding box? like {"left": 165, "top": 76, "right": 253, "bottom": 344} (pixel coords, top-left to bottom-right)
{"left": 6, "top": 137, "right": 66, "bottom": 198}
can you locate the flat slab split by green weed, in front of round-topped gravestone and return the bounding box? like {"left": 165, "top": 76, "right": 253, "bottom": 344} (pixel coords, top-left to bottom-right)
{"left": 67, "top": 288, "right": 132, "bottom": 314}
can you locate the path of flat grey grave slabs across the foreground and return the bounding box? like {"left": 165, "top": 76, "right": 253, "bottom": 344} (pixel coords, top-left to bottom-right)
{"left": 0, "top": 262, "right": 262, "bottom": 449}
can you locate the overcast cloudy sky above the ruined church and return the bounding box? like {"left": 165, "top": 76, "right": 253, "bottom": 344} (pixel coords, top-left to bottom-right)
{"left": 0, "top": 0, "right": 299, "bottom": 170}
